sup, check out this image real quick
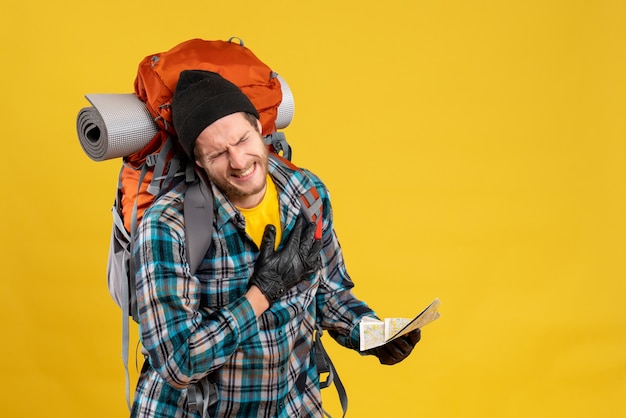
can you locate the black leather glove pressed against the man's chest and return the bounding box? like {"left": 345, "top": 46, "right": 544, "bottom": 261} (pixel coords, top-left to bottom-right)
{"left": 248, "top": 215, "right": 322, "bottom": 305}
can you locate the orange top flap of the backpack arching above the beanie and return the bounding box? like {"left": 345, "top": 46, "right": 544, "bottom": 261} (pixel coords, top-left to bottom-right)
{"left": 135, "top": 38, "right": 282, "bottom": 135}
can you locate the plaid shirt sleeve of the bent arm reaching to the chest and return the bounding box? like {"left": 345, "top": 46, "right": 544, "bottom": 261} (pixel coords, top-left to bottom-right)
{"left": 134, "top": 199, "right": 258, "bottom": 388}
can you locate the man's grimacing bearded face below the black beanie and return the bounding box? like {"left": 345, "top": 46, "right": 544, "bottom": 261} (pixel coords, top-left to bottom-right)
{"left": 196, "top": 113, "right": 268, "bottom": 208}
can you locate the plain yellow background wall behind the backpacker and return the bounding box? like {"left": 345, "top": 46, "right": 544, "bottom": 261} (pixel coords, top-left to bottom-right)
{"left": 0, "top": 0, "right": 626, "bottom": 418}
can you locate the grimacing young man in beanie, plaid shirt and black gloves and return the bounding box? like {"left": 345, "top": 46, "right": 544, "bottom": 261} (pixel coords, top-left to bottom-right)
{"left": 132, "top": 70, "right": 420, "bottom": 418}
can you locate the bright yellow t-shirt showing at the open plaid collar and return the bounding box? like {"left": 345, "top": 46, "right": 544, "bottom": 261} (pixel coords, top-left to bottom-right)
{"left": 237, "top": 175, "right": 282, "bottom": 248}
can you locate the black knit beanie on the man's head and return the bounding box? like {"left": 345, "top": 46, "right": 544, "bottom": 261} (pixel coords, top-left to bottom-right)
{"left": 172, "top": 70, "right": 259, "bottom": 161}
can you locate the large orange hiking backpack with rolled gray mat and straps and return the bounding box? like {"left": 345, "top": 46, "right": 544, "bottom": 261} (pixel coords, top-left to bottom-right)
{"left": 77, "top": 38, "right": 347, "bottom": 417}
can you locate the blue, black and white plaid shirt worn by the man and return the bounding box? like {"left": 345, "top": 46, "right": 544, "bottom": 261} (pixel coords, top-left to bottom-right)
{"left": 132, "top": 157, "right": 375, "bottom": 418}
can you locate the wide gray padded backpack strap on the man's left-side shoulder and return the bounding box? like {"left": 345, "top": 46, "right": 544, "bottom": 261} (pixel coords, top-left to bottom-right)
{"left": 183, "top": 178, "right": 213, "bottom": 274}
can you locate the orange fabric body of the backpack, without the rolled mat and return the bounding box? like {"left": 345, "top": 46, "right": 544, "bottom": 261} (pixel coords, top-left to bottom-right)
{"left": 119, "top": 38, "right": 289, "bottom": 232}
